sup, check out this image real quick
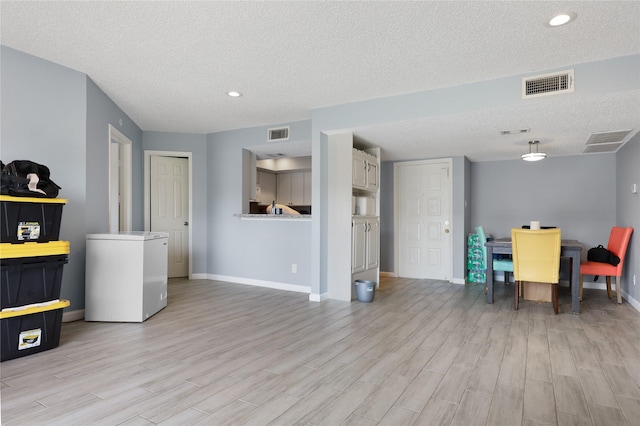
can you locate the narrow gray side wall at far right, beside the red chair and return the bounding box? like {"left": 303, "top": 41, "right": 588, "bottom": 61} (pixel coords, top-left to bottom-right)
{"left": 616, "top": 133, "right": 640, "bottom": 303}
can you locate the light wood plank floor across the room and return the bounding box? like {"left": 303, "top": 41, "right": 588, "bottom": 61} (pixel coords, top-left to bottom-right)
{"left": 0, "top": 278, "right": 640, "bottom": 426}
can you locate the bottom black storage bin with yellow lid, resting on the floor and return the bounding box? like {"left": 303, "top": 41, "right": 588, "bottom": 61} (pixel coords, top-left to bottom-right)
{"left": 0, "top": 300, "right": 69, "bottom": 361}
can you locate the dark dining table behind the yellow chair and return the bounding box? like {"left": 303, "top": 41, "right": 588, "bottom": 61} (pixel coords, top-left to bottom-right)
{"left": 485, "top": 238, "right": 582, "bottom": 315}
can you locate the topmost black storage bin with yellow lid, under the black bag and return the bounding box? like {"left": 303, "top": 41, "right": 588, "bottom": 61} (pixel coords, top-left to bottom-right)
{"left": 0, "top": 195, "right": 66, "bottom": 244}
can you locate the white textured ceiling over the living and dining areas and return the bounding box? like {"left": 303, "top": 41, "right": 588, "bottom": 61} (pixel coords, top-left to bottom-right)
{"left": 0, "top": 1, "right": 640, "bottom": 161}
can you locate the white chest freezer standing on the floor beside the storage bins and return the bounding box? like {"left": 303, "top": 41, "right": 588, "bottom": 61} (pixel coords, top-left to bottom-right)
{"left": 84, "top": 231, "right": 169, "bottom": 322}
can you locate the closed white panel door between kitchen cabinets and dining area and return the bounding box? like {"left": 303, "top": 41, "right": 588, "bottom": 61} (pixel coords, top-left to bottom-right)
{"left": 395, "top": 161, "right": 452, "bottom": 280}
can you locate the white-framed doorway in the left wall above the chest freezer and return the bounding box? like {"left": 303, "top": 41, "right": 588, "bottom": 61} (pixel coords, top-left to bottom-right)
{"left": 109, "top": 124, "right": 132, "bottom": 232}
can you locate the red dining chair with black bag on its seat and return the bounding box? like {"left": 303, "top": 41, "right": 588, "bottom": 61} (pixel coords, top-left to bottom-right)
{"left": 580, "top": 226, "right": 633, "bottom": 304}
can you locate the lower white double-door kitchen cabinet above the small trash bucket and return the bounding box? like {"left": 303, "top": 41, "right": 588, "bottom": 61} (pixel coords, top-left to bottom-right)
{"left": 351, "top": 216, "right": 380, "bottom": 274}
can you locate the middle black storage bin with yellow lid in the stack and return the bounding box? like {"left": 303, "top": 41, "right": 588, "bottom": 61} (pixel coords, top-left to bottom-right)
{"left": 0, "top": 241, "right": 69, "bottom": 309}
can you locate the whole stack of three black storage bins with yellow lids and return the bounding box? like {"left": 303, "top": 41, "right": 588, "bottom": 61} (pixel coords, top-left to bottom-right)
{"left": 0, "top": 195, "right": 69, "bottom": 361}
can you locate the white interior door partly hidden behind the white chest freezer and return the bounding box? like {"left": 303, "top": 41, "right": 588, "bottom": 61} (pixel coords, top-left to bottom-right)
{"left": 150, "top": 155, "right": 189, "bottom": 278}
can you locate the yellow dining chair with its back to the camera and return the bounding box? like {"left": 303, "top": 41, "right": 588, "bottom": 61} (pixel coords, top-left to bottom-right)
{"left": 511, "top": 228, "right": 562, "bottom": 314}
